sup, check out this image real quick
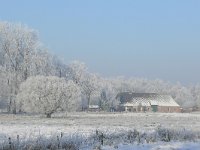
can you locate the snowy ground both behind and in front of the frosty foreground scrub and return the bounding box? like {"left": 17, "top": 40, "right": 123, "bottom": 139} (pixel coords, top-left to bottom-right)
{"left": 0, "top": 112, "right": 200, "bottom": 150}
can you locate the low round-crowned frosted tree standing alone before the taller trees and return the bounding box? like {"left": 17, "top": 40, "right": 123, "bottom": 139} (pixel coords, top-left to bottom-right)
{"left": 17, "top": 76, "right": 80, "bottom": 117}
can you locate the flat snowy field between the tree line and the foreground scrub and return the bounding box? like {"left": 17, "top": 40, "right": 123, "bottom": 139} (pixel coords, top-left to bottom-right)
{"left": 0, "top": 112, "right": 200, "bottom": 137}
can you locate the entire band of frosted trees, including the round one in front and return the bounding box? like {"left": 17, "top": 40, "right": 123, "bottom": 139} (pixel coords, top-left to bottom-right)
{"left": 0, "top": 22, "right": 200, "bottom": 117}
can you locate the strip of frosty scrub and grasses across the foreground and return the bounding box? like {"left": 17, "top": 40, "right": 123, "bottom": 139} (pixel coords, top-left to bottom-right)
{"left": 0, "top": 127, "right": 200, "bottom": 150}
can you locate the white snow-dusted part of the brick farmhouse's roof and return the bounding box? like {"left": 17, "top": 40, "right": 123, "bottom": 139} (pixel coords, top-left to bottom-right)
{"left": 120, "top": 93, "right": 179, "bottom": 106}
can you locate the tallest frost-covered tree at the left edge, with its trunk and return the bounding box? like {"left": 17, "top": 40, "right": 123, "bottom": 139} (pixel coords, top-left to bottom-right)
{"left": 0, "top": 22, "right": 38, "bottom": 113}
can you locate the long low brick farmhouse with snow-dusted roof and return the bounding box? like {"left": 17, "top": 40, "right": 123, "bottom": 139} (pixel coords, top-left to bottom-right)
{"left": 116, "top": 92, "right": 181, "bottom": 113}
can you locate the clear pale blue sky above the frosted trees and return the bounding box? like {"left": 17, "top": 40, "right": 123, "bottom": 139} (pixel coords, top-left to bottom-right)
{"left": 0, "top": 0, "right": 200, "bottom": 84}
